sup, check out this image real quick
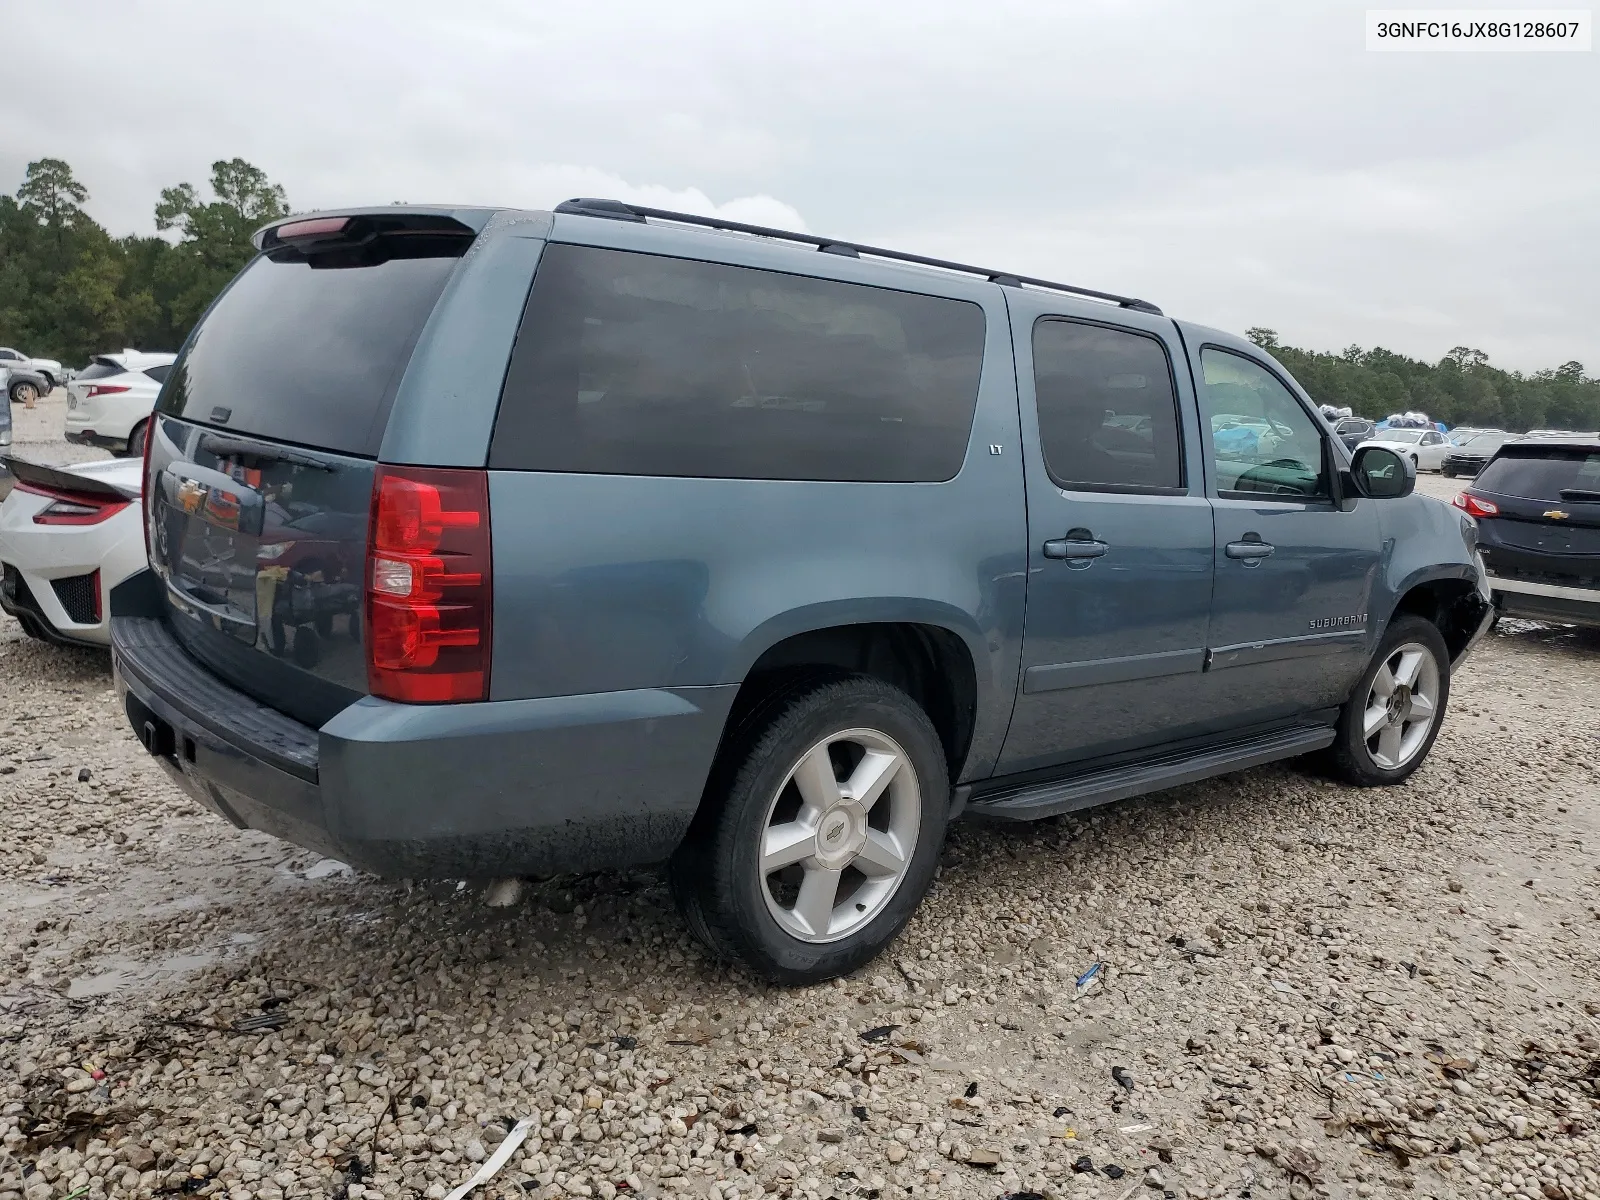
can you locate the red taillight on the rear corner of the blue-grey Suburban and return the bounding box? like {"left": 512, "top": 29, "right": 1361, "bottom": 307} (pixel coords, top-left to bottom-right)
{"left": 366, "top": 466, "right": 494, "bottom": 704}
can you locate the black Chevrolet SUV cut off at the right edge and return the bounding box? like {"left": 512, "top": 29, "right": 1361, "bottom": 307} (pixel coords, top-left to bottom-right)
{"left": 1454, "top": 434, "right": 1600, "bottom": 626}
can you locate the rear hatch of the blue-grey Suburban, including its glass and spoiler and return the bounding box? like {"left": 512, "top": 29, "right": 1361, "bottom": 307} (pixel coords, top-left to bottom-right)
{"left": 146, "top": 211, "right": 474, "bottom": 725}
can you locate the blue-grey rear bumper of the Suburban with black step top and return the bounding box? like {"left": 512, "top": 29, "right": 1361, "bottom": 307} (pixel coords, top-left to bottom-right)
{"left": 110, "top": 616, "right": 738, "bottom": 878}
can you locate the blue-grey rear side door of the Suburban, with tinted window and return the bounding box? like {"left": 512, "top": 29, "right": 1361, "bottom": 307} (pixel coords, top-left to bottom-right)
{"left": 997, "top": 291, "right": 1214, "bottom": 773}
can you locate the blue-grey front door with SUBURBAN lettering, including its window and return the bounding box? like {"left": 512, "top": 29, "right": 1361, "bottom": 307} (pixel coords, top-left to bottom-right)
{"left": 1184, "top": 340, "right": 1379, "bottom": 726}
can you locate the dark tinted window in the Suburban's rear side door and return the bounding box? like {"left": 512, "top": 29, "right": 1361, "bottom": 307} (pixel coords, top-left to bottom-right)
{"left": 1034, "top": 318, "right": 1184, "bottom": 493}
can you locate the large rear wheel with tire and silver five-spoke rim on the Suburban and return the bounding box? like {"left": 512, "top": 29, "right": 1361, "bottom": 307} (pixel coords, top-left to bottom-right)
{"left": 669, "top": 677, "right": 950, "bottom": 984}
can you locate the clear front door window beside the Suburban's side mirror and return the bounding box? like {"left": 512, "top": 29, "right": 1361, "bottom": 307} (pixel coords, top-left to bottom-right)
{"left": 1200, "top": 347, "right": 1331, "bottom": 499}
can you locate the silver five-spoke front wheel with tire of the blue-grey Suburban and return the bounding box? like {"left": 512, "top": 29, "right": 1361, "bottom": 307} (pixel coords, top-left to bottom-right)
{"left": 1333, "top": 616, "right": 1450, "bottom": 787}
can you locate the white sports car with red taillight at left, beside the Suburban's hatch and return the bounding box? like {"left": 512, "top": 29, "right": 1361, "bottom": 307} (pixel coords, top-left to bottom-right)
{"left": 0, "top": 458, "right": 146, "bottom": 646}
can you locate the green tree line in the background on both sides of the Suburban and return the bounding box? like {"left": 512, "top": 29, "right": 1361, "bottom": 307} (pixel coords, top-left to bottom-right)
{"left": 0, "top": 158, "right": 1600, "bottom": 430}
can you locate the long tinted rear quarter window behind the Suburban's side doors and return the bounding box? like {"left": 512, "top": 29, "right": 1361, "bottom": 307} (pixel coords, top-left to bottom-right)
{"left": 490, "top": 245, "right": 984, "bottom": 483}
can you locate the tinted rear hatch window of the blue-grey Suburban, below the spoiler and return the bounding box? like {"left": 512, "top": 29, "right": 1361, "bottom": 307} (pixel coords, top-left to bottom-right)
{"left": 160, "top": 237, "right": 467, "bottom": 458}
